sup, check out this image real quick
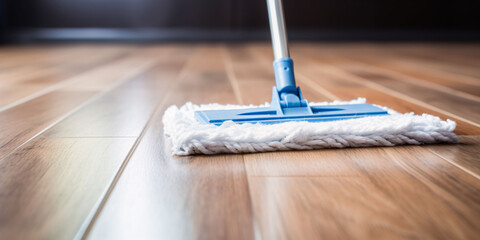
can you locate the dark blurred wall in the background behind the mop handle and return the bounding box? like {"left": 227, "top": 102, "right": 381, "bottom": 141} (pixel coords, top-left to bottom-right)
{"left": 0, "top": 0, "right": 480, "bottom": 40}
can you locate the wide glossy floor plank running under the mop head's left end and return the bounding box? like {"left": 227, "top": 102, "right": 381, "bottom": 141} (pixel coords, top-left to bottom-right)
{"left": 86, "top": 46, "right": 254, "bottom": 239}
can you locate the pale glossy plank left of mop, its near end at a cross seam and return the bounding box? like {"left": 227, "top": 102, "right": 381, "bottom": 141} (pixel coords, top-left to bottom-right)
{"left": 44, "top": 55, "right": 185, "bottom": 137}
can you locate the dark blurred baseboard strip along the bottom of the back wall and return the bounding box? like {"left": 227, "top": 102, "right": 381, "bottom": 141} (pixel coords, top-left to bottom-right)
{"left": 5, "top": 28, "right": 480, "bottom": 43}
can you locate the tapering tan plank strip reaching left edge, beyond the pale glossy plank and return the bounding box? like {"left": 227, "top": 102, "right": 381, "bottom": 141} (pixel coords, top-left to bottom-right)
{"left": 0, "top": 56, "right": 153, "bottom": 159}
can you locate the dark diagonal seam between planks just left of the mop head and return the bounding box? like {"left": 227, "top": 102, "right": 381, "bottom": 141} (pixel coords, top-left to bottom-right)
{"left": 78, "top": 47, "right": 193, "bottom": 240}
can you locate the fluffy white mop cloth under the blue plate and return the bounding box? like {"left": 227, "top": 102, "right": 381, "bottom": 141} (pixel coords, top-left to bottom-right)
{"left": 163, "top": 98, "right": 459, "bottom": 155}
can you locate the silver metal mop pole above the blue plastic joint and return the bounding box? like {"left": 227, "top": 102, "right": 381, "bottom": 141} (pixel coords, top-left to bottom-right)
{"left": 267, "top": 0, "right": 290, "bottom": 59}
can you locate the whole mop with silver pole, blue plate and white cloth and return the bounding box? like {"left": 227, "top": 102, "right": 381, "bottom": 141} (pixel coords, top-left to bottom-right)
{"left": 162, "top": 0, "right": 459, "bottom": 155}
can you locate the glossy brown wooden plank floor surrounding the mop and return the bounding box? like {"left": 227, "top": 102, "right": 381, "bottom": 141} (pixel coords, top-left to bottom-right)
{"left": 0, "top": 43, "right": 480, "bottom": 240}
